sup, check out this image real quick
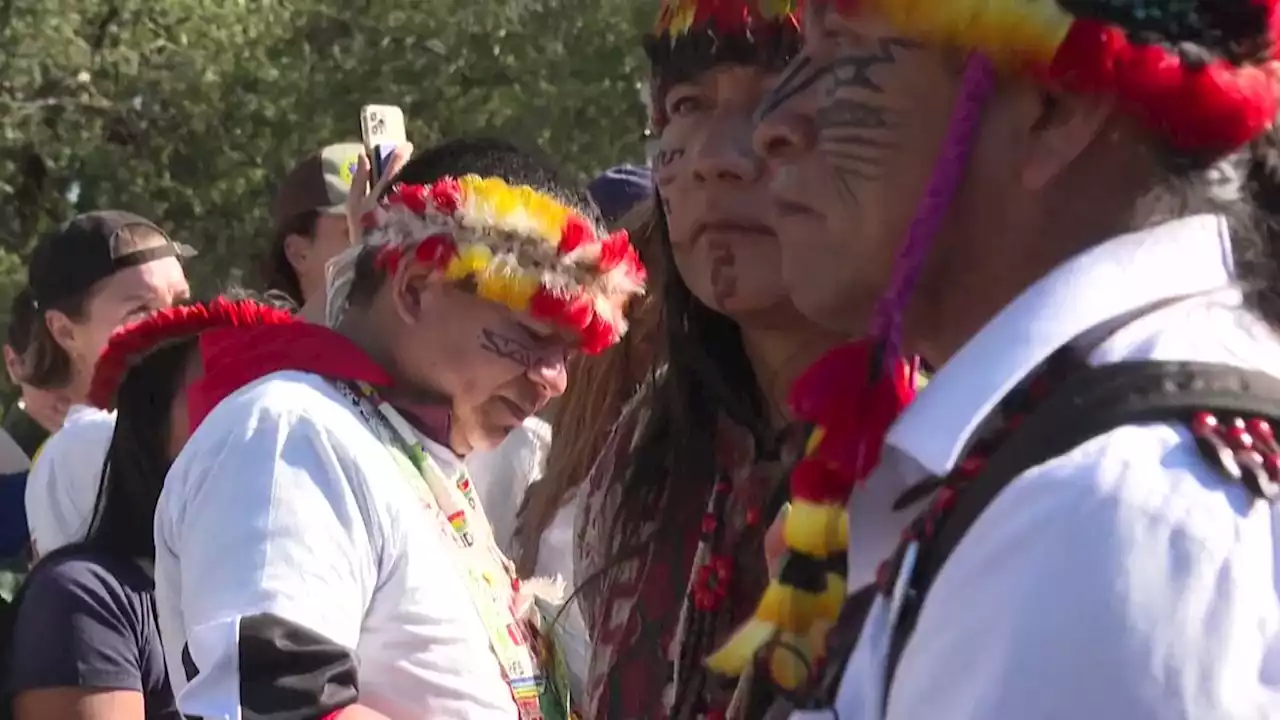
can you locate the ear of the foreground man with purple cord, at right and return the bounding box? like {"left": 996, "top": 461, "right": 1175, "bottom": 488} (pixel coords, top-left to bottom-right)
{"left": 1021, "top": 90, "right": 1115, "bottom": 191}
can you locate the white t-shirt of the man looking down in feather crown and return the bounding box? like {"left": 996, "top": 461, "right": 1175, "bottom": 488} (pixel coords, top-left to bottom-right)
{"left": 156, "top": 372, "right": 516, "bottom": 720}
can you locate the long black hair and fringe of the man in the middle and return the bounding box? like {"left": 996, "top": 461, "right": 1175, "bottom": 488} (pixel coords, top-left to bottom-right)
{"left": 591, "top": 8, "right": 800, "bottom": 548}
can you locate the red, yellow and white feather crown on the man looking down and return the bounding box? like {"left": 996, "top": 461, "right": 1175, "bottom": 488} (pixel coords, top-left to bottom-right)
{"left": 364, "top": 176, "right": 645, "bottom": 354}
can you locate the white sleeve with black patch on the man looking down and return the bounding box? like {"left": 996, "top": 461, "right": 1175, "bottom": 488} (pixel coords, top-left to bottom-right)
{"left": 156, "top": 393, "right": 381, "bottom": 716}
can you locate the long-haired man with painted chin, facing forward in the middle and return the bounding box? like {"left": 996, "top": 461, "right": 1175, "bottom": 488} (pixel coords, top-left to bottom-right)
{"left": 575, "top": 0, "right": 855, "bottom": 720}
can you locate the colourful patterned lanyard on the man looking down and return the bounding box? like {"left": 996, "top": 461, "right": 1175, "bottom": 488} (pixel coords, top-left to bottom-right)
{"left": 335, "top": 383, "right": 547, "bottom": 720}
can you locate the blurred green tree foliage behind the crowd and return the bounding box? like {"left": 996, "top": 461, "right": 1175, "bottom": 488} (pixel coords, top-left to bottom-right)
{"left": 0, "top": 0, "right": 655, "bottom": 356}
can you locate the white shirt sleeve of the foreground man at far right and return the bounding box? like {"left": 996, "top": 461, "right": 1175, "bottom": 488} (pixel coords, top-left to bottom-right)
{"left": 875, "top": 428, "right": 1280, "bottom": 720}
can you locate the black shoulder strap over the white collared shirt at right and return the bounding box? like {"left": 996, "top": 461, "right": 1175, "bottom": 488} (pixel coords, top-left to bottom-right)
{"left": 884, "top": 361, "right": 1280, "bottom": 698}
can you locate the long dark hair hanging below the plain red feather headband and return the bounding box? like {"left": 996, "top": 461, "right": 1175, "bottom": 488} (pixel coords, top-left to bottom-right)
{"left": 84, "top": 337, "right": 198, "bottom": 560}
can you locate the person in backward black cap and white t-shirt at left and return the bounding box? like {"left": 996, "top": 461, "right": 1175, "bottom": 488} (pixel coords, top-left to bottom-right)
{"left": 20, "top": 210, "right": 195, "bottom": 555}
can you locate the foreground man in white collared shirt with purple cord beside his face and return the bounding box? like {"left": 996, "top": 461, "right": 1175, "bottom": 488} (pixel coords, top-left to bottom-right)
{"left": 716, "top": 0, "right": 1280, "bottom": 720}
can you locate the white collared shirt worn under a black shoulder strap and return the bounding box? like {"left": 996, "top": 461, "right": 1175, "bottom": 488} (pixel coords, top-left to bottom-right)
{"left": 795, "top": 215, "right": 1280, "bottom": 720}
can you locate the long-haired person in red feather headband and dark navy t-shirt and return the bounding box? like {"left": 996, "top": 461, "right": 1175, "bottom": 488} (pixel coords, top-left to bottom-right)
{"left": 6, "top": 294, "right": 292, "bottom": 720}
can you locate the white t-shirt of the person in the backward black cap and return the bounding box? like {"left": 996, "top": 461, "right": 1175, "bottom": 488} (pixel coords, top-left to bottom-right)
{"left": 26, "top": 405, "right": 115, "bottom": 555}
